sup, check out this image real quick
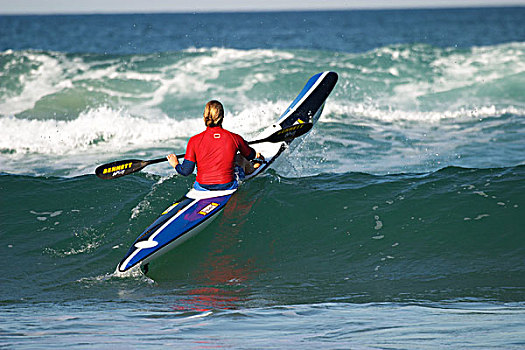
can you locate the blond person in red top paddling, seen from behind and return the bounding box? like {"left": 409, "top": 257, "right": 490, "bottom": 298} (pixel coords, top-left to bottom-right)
{"left": 167, "top": 100, "right": 264, "bottom": 190}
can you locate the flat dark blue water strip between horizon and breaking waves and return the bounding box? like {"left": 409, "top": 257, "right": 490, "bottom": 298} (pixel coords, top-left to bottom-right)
{"left": 0, "top": 7, "right": 525, "bottom": 54}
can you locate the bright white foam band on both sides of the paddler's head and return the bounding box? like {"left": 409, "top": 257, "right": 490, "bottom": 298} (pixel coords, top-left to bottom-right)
{"left": 0, "top": 97, "right": 284, "bottom": 155}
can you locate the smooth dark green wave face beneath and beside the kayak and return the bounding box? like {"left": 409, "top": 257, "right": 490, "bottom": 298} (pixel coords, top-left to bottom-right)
{"left": 0, "top": 166, "right": 525, "bottom": 306}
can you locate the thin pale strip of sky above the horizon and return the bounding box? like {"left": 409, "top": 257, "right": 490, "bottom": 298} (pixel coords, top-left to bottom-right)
{"left": 0, "top": 0, "right": 525, "bottom": 14}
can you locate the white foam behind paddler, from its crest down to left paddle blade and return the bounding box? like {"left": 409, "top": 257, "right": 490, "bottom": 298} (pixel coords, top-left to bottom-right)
{"left": 0, "top": 98, "right": 286, "bottom": 176}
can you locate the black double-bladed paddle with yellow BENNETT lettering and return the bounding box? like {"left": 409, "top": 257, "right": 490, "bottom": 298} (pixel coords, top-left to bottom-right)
{"left": 95, "top": 123, "right": 313, "bottom": 180}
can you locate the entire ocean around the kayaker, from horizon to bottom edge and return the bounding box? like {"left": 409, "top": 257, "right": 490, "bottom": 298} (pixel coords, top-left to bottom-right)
{"left": 0, "top": 7, "right": 525, "bottom": 349}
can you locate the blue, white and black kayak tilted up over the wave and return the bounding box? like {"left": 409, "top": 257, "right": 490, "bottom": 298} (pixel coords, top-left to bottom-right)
{"left": 117, "top": 72, "right": 338, "bottom": 273}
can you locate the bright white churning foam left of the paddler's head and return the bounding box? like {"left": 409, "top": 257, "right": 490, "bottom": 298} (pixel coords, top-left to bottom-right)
{"left": 0, "top": 107, "right": 202, "bottom": 155}
